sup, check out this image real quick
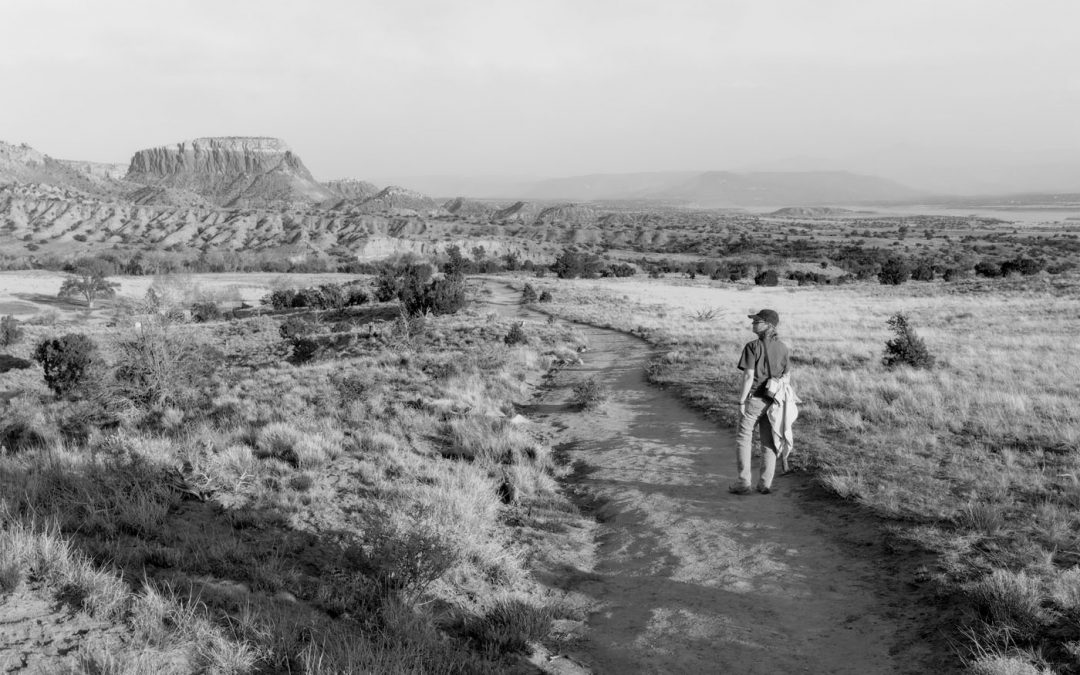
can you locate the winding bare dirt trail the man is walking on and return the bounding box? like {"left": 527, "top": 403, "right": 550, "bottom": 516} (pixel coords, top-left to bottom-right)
{"left": 489, "top": 284, "right": 942, "bottom": 674}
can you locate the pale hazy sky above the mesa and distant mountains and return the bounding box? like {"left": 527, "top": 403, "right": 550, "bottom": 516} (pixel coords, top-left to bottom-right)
{"left": 0, "top": 0, "right": 1080, "bottom": 190}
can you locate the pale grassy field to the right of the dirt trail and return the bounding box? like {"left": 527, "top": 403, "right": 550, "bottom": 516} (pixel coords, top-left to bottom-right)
{"left": 528, "top": 271, "right": 1080, "bottom": 673}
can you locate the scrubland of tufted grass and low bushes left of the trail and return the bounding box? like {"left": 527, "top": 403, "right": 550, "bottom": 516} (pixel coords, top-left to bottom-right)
{"left": 0, "top": 275, "right": 590, "bottom": 673}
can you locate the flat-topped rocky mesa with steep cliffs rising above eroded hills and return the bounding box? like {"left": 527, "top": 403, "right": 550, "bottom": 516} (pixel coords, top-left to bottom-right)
{"left": 126, "top": 137, "right": 334, "bottom": 207}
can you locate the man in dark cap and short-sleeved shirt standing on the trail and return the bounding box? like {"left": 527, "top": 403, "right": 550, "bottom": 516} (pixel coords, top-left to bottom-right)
{"left": 729, "top": 309, "right": 789, "bottom": 495}
